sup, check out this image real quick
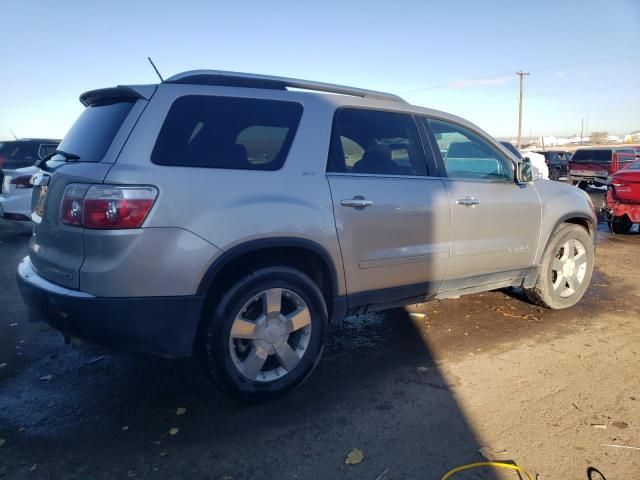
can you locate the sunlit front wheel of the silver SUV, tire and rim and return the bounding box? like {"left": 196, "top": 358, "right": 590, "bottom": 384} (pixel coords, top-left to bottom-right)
{"left": 524, "top": 224, "right": 594, "bottom": 309}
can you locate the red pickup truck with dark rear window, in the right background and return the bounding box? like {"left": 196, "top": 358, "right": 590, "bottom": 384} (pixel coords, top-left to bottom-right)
{"left": 569, "top": 147, "right": 636, "bottom": 189}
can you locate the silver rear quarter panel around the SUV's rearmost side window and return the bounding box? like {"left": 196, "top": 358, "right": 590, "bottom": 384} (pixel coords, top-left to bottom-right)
{"left": 106, "top": 85, "right": 345, "bottom": 295}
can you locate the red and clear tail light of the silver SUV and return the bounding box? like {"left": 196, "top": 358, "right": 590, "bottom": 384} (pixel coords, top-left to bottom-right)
{"left": 60, "top": 184, "right": 158, "bottom": 230}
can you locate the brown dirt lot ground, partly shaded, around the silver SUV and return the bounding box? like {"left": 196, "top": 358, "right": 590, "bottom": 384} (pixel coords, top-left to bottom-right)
{"left": 0, "top": 191, "right": 640, "bottom": 480}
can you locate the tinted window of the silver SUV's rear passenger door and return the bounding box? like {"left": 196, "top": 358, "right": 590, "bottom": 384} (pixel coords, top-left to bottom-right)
{"left": 327, "top": 108, "right": 427, "bottom": 176}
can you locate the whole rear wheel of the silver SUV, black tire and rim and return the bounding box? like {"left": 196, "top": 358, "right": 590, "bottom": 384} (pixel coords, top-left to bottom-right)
{"left": 204, "top": 267, "right": 329, "bottom": 401}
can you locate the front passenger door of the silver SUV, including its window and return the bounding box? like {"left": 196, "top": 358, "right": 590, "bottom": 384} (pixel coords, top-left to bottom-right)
{"left": 422, "top": 117, "right": 541, "bottom": 281}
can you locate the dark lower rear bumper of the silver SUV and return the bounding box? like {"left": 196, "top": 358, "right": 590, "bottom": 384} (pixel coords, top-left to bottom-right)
{"left": 17, "top": 257, "right": 204, "bottom": 357}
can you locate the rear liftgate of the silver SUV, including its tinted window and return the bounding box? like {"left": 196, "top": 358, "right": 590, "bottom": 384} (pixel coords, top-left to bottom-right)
{"left": 29, "top": 92, "right": 147, "bottom": 289}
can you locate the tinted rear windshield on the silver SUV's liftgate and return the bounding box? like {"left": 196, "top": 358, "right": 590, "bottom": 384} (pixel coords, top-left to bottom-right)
{"left": 53, "top": 101, "right": 134, "bottom": 162}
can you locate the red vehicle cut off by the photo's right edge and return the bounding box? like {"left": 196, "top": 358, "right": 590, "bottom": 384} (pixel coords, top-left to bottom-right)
{"left": 602, "top": 160, "right": 640, "bottom": 233}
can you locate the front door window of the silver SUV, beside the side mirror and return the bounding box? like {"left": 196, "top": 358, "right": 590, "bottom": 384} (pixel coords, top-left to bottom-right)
{"left": 425, "top": 119, "right": 513, "bottom": 182}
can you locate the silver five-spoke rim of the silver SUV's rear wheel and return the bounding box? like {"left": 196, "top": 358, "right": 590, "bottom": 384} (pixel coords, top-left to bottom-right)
{"left": 229, "top": 288, "right": 311, "bottom": 382}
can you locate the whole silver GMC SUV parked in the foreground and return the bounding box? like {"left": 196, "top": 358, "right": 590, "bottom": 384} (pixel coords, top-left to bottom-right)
{"left": 18, "top": 71, "right": 596, "bottom": 400}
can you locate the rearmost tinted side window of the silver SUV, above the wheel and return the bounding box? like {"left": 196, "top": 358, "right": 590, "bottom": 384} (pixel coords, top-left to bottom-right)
{"left": 151, "top": 95, "right": 302, "bottom": 170}
